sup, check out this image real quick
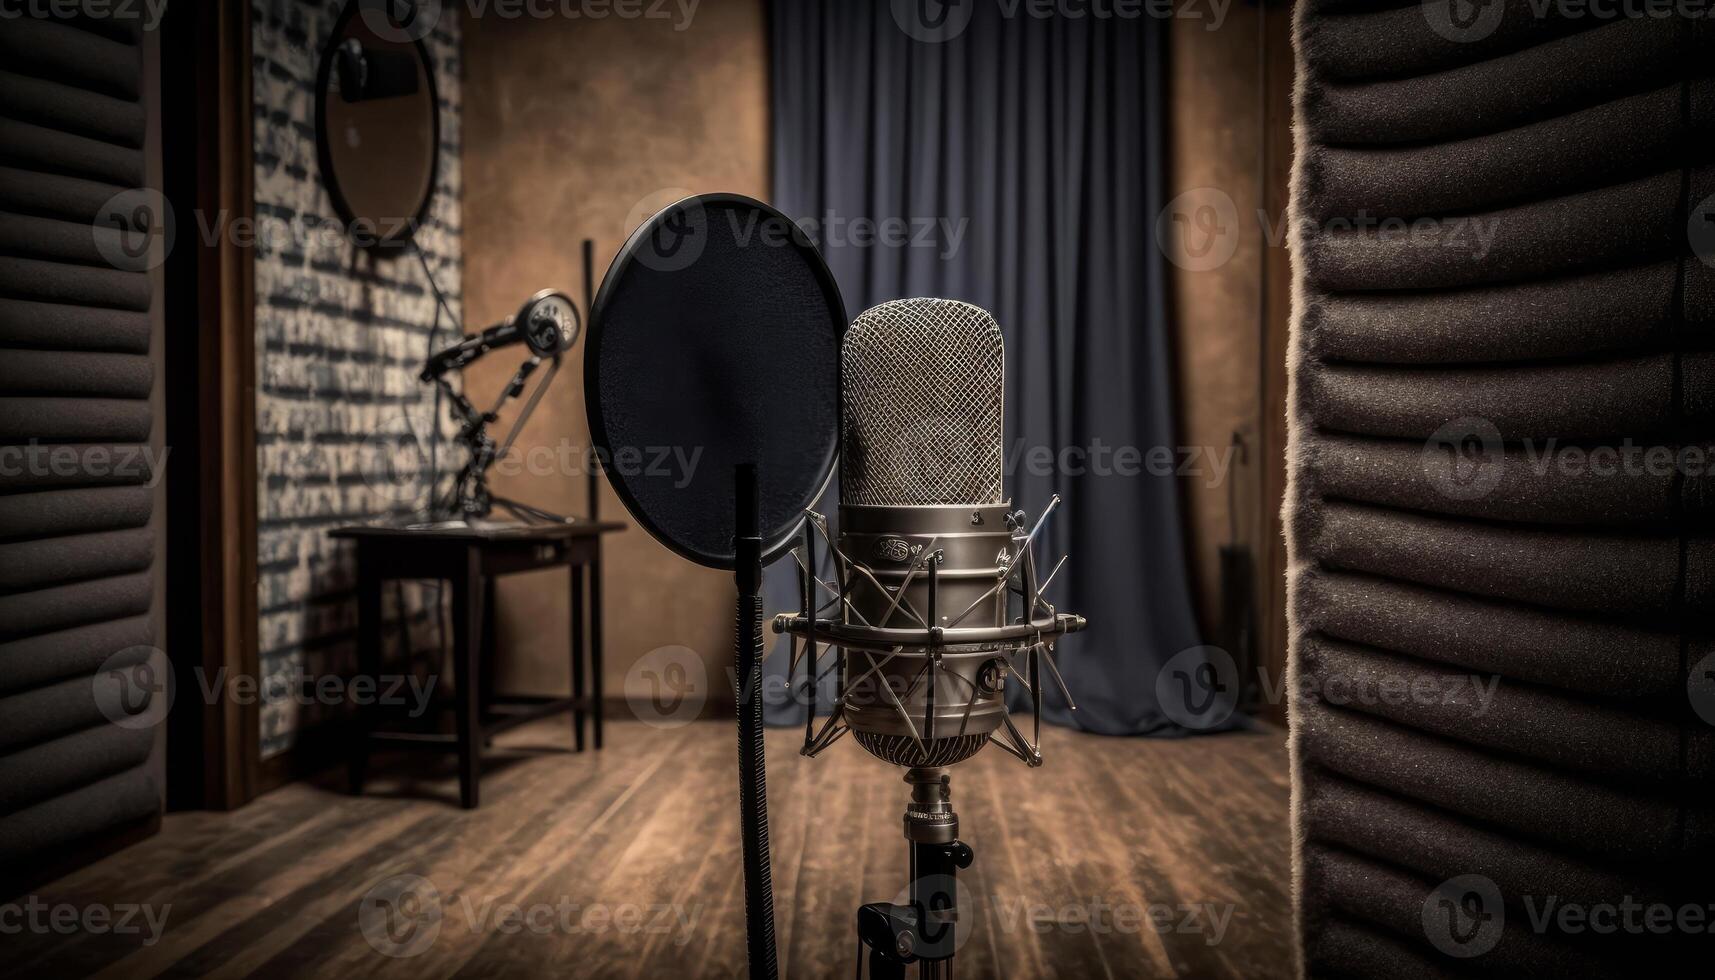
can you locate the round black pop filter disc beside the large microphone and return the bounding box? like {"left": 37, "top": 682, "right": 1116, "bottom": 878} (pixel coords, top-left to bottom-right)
{"left": 583, "top": 194, "right": 845, "bottom": 568}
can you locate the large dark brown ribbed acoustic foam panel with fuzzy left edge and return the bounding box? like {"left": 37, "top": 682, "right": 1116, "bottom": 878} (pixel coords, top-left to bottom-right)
{"left": 1286, "top": 0, "right": 1715, "bottom": 978}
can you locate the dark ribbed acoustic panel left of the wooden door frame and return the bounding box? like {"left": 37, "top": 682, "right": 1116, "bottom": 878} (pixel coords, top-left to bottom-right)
{"left": 0, "top": 15, "right": 159, "bottom": 872}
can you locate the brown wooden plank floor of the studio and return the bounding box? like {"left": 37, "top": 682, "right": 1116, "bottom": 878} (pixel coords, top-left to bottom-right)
{"left": 10, "top": 719, "right": 1291, "bottom": 980}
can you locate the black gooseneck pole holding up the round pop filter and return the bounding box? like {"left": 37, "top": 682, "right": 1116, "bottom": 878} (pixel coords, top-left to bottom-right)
{"left": 732, "top": 463, "right": 780, "bottom": 980}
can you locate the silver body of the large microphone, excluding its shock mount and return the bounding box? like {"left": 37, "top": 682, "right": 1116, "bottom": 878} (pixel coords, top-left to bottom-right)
{"left": 840, "top": 299, "right": 1017, "bottom": 765}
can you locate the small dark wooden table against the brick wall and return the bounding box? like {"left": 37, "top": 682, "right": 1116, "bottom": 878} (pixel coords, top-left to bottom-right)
{"left": 329, "top": 522, "right": 624, "bottom": 808}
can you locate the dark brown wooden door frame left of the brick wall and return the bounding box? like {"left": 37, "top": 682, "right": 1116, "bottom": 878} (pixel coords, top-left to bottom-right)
{"left": 161, "top": 3, "right": 261, "bottom": 810}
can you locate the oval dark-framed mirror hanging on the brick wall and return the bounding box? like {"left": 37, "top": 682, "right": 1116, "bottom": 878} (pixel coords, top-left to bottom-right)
{"left": 316, "top": 2, "right": 441, "bottom": 247}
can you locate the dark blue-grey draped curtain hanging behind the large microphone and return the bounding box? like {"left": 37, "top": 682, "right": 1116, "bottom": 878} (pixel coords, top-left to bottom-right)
{"left": 768, "top": 0, "right": 1199, "bottom": 735}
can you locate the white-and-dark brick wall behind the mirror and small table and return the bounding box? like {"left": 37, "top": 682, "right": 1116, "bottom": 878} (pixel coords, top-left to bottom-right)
{"left": 252, "top": 0, "right": 463, "bottom": 759}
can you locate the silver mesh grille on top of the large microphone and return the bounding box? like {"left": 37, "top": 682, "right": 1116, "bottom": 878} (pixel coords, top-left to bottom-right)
{"left": 840, "top": 299, "right": 1005, "bottom": 506}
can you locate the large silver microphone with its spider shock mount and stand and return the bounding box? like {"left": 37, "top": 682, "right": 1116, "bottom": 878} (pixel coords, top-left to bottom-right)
{"left": 773, "top": 299, "right": 1084, "bottom": 980}
